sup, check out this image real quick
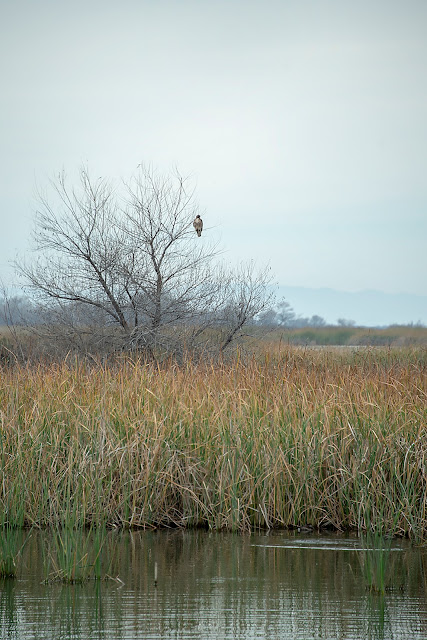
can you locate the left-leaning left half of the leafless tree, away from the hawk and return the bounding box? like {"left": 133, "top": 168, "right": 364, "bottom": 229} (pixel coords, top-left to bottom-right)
{"left": 17, "top": 169, "right": 129, "bottom": 331}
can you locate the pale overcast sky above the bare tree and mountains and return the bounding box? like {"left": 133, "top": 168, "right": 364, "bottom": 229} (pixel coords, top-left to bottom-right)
{"left": 0, "top": 0, "right": 427, "bottom": 295}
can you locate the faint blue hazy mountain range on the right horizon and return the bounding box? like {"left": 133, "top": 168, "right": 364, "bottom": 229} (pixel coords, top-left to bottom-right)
{"left": 277, "top": 285, "right": 427, "bottom": 327}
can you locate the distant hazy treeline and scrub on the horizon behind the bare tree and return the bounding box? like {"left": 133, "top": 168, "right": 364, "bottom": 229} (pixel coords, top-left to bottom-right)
{"left": 0, "top": 297, "right": 427, "bottom": 364}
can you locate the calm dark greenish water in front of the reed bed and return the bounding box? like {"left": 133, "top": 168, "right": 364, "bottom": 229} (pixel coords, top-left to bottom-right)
{"left": 0, "top": 531, "right": 427, "bottom": 640}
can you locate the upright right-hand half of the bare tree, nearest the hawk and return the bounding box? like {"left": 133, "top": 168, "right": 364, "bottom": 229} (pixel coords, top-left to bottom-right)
{"left": 120, "top": 169, "right": 224, "bottom": 346}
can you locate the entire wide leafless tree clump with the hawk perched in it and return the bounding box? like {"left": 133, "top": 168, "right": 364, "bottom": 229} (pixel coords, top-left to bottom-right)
{"left": 16, "top": 166, "right": 269, "bottom": 357}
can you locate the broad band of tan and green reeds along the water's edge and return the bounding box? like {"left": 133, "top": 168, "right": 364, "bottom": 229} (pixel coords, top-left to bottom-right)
{"left": 0, "top": 348, "right": 427, "bottom": 537}
